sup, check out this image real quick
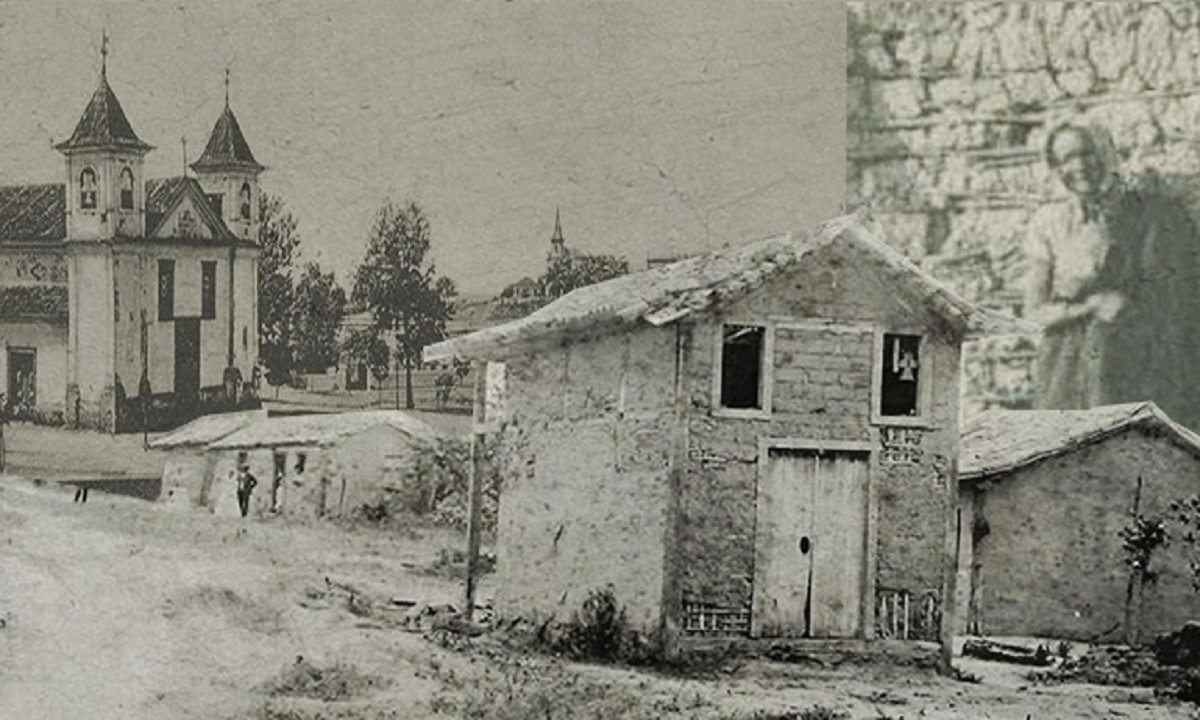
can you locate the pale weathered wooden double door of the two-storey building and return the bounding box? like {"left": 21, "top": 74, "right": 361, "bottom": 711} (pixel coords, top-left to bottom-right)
{"left": 752, "top": 449, "right": 868, "bottom": 637}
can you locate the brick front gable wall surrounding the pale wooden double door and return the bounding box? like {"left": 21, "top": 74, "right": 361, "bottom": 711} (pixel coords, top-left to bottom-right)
{"left": 678, "top": 242, "right": 959, "bottom": 622}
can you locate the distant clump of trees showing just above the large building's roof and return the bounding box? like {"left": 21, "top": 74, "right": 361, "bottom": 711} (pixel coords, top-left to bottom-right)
{"left": 492, "top": 247, "right": 629, "bottom": 318}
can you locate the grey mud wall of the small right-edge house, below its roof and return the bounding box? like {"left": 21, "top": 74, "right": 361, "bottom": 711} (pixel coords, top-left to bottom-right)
{"left": 974, "top": 430, "right": 1200, "bottom": 640}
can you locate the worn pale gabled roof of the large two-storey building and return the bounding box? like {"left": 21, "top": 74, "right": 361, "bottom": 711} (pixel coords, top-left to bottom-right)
{"left": 425, "top": 215, "right": 1039, "bottom": 361}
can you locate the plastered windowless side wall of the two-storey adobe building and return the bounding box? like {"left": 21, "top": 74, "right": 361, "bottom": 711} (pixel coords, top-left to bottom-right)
{"left": 496, "top": 326, "right": 676, "bottom": 630}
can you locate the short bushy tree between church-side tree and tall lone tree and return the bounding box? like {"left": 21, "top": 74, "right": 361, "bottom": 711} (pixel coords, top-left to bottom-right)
{"left": 290, "top": 263, "right": 346, "bottom": 372}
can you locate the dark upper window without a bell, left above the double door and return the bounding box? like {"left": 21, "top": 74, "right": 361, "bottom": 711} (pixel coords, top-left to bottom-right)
{"left": 714, "top": 324, "right": 772, "bottom": 414}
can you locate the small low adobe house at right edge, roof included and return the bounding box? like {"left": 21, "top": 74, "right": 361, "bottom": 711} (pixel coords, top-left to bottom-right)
{"left": 958, "top": 402, "right": 1200, "bottom": 641}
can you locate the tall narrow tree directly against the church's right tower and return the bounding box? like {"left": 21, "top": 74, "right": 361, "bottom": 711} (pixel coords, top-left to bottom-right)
{"left": 258, "top": 192, "right": 300, "bottom": 388}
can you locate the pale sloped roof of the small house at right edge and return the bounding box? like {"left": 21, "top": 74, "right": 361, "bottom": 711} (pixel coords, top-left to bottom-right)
{"left": 959, "top": 402, "right": 1200, "bottom": 480}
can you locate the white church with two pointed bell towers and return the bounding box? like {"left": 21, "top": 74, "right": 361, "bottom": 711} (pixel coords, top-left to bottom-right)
{"left": 0, "top": 54, "right": 265, "bottom": 432}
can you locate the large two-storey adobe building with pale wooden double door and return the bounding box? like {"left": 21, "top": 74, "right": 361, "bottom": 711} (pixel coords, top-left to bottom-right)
{"left": 425, "top": 211, "right": 1028, "bottom": 653}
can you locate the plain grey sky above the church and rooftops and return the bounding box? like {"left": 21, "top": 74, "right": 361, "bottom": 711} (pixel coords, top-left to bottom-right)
{"left": 0, "top": 0, "right": 846, "bottom": 295}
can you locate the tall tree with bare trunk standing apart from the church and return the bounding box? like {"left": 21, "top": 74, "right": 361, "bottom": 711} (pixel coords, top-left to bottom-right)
{"left": 353, "top": 202, "right": 457, "bottom": 409}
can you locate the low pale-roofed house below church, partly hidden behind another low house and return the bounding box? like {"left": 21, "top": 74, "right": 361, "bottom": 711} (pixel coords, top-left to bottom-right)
{"left": 149, "top": 409, "right": 266, "bottom": 508}
